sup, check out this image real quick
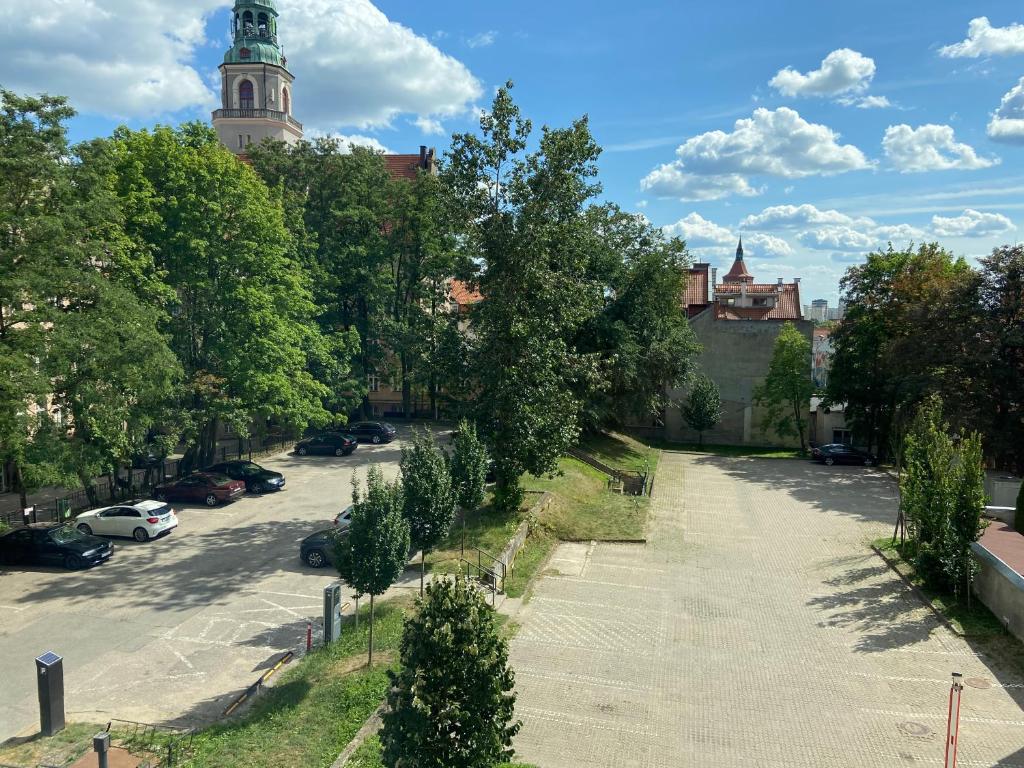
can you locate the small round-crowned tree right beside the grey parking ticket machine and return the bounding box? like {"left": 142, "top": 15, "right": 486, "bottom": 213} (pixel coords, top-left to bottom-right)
{"left": 336, "top": 466, "right": 410, "bottom": 665}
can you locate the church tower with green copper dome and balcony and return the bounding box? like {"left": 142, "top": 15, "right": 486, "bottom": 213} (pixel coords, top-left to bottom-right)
{"left": 213, "top": 0, "right": 302, "bottom": 155}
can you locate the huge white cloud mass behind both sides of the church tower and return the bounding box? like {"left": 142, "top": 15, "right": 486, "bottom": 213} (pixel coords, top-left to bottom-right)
{"left": 0, "top": 0, "right": 483, "bottom": 130}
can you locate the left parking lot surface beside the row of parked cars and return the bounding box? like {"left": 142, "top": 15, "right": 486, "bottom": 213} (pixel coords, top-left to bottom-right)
{"left": 0, "top": 429, "right": 436, "bottom": 741}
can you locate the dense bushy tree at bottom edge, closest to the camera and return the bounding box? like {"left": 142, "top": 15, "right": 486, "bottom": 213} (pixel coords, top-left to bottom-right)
{"left": 381, "top": 579, "right": 521, "bottom": 768}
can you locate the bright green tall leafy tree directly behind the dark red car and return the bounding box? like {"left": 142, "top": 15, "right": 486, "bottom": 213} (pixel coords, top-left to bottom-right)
{"left": 104, "top": 124, "right": 331, "bottom": 466}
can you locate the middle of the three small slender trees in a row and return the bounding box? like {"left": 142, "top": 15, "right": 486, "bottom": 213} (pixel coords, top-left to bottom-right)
{"left": 401, "top": 430, "right": 456, "bottom": 595}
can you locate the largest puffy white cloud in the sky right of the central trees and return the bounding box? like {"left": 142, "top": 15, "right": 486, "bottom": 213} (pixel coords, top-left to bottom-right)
{"left": 641, "top": 106, "right": 871, "bottom": 200}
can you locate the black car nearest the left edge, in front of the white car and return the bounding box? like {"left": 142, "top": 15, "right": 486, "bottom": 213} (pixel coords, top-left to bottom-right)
{"left": 0, "top": 522, "right": 114, "bottom": 570}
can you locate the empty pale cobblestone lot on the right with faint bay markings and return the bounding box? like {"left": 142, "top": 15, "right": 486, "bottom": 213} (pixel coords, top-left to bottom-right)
{"left": 512, "top": 454, "right": 1024, "bottom": 768}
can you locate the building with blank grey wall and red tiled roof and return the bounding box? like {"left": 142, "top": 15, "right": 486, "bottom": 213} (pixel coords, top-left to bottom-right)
{"left": 664, "top": 241, "right": 814, "bottom": 445}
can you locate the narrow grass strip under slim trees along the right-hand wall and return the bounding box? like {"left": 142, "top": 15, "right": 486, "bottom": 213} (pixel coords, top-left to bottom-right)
{"left": 872, "top": 537, "right": 1024, "bottom": 676}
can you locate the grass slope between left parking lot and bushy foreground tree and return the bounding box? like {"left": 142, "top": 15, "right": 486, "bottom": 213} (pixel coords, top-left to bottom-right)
{"left": 181, "top": 600, "right": 410, "bottom": 768}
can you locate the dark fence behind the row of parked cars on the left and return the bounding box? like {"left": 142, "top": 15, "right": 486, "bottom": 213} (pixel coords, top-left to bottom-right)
{"left": 0, "top": 435, "right": 294, "bottom": 525}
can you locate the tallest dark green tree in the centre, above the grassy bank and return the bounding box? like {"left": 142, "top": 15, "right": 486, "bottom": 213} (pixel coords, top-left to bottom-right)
{"left": 444, "top": 84, "right": 602, "bottom": 510}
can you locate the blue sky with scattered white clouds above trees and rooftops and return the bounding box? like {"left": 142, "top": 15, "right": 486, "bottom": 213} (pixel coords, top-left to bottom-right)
{"left": 0, "top": 0, "right": 1024, "bottom": 304}
